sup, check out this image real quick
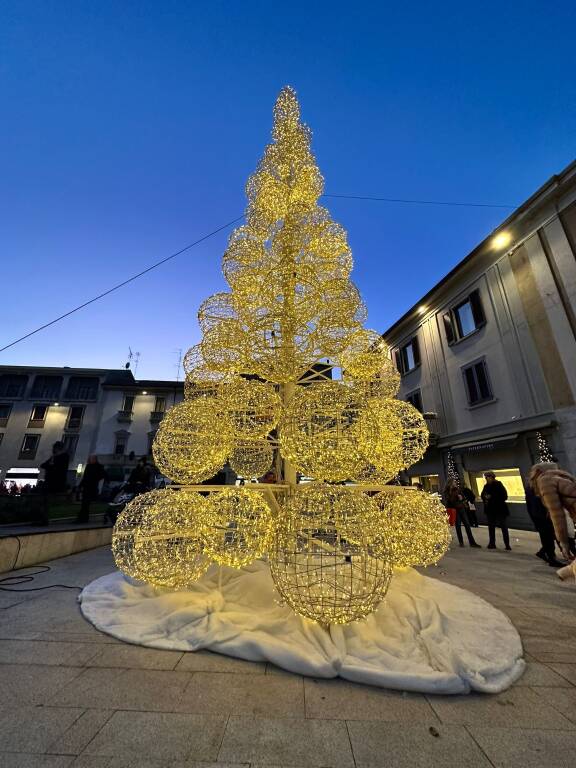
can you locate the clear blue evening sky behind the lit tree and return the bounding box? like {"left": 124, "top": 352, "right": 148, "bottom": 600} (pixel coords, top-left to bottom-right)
{"left": 0, "top": 0, "right": 576, "bottom": 378}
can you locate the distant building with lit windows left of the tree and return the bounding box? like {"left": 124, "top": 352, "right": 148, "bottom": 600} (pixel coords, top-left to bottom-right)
{"left": 0, "top": 366, "right": 184, "bottom": 485}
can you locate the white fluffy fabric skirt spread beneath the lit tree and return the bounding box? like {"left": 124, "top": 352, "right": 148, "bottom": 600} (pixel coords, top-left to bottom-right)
{"left": 79, "top": 561, "right": 525, "bottom": 693}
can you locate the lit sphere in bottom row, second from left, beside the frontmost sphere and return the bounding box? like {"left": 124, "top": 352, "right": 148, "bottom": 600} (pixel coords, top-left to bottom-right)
{"left": 204, "top": 488, "right": 272, "bottom": 568}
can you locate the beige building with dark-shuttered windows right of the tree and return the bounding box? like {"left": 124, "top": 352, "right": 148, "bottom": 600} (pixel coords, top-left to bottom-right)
{"left": 383, "top": 156, "right": 576, "bottom": 524}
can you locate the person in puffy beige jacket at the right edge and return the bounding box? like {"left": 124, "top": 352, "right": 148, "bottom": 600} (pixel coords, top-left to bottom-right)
{"left": 528, "top": 462, "right": 576, "bottom": 560}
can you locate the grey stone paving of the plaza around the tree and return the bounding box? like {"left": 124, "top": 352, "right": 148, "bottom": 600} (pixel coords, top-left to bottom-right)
{"left": 0, "top": 529, "right": 576, "bottom": 768}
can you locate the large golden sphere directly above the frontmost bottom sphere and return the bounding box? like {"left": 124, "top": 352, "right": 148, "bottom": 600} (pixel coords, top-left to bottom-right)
{"left": 279, "top": 381, "right": 379, "bottom": 482}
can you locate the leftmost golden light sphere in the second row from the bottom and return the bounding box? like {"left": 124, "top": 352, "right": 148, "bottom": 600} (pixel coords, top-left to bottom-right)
{"left": 152, "top": 397, "right": 233, "bottom": 484}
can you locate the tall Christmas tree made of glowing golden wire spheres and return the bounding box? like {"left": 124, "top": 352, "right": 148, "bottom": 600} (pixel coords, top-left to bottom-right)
{"left": 113, "top": 88, "right": 450, "bottom": 625}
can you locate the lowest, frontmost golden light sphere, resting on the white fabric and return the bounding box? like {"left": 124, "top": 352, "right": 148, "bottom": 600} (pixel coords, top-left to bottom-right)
{"left": 269, "top": 486, "right": 392, "bottom": 625}
